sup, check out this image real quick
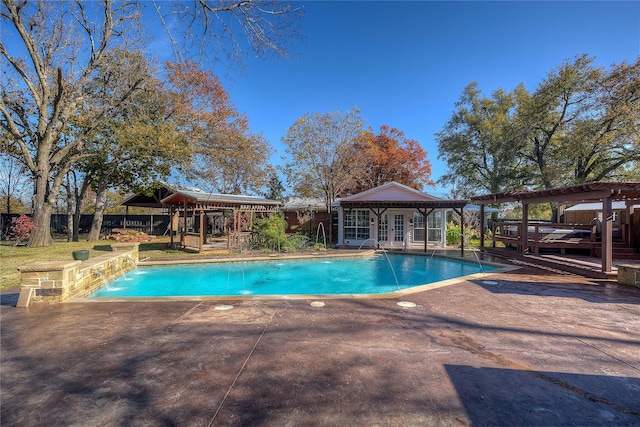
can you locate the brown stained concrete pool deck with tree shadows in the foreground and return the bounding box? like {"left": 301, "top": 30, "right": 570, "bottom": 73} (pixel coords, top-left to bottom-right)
{"left": 0, "top": 267, "right": 640, "bottom": 426}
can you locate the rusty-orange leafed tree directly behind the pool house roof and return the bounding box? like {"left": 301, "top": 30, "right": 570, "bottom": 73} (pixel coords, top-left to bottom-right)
{"left": 347, "top": 125, "right": 434, "bottom": 194}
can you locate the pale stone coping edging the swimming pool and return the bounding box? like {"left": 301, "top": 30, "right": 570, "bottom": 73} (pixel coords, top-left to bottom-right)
{"left": 67, "top": 249, "right": 522, "bottom": 303}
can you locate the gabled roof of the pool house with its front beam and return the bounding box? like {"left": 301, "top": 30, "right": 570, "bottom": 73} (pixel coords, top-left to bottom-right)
{"left": 334, "top": 181, "right": 468, "bottom": 208}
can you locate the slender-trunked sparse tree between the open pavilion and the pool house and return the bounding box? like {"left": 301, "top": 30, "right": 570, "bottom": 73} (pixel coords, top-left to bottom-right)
{"left": 282, "top": 107, "right": 365, "bottom": 244}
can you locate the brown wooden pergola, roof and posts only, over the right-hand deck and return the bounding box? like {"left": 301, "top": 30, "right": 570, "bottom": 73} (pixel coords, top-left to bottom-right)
{"left": 471, "top": 182, "right": 640, "bottom": 273}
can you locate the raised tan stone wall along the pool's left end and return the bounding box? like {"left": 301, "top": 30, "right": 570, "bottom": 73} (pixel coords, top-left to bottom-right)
{"left": 16, "top": 242, "right": 140, "bottom": 307}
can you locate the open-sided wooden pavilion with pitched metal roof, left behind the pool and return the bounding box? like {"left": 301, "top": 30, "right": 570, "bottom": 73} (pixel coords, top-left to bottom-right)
{"left": 122, "top": 184, "right": 281, "bottom": 252}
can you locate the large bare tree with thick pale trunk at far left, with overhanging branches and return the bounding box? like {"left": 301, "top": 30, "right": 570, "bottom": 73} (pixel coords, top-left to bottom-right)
{"left": 0, "top": 0, "right": 300, "bottom": 246}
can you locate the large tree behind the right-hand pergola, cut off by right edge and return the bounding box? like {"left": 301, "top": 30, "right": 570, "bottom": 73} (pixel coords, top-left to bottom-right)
{"left": 518, "top": 55, "right": 640, "bottom": 188}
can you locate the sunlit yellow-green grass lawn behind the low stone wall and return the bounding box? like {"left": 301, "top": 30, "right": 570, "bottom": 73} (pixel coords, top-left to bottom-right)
{"left": 0, "top": 237, "right": 218, "bottom": 291}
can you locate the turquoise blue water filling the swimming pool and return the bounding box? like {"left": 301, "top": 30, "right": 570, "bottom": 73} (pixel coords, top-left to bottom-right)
{"left": 89, "top": 254, "right": 495, "bottom": 297}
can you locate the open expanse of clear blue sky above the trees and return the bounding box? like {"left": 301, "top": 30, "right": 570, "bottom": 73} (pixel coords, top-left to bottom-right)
{"left": 206, "top": 1, "right": 640, "bottom": 196}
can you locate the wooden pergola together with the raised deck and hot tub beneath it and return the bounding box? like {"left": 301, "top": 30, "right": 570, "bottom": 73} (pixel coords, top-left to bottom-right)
{"left": 471, "top": 182, "right": 640, "bottom": 275}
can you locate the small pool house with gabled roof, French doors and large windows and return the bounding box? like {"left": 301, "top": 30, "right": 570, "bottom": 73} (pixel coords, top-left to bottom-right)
{"left": 333, "top": 182, "right": 468, "bottom": 252}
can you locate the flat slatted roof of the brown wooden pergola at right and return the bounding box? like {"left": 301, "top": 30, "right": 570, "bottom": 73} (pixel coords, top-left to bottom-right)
{"left": 471, "top": 181, "right": 640, "bottom": 205}
